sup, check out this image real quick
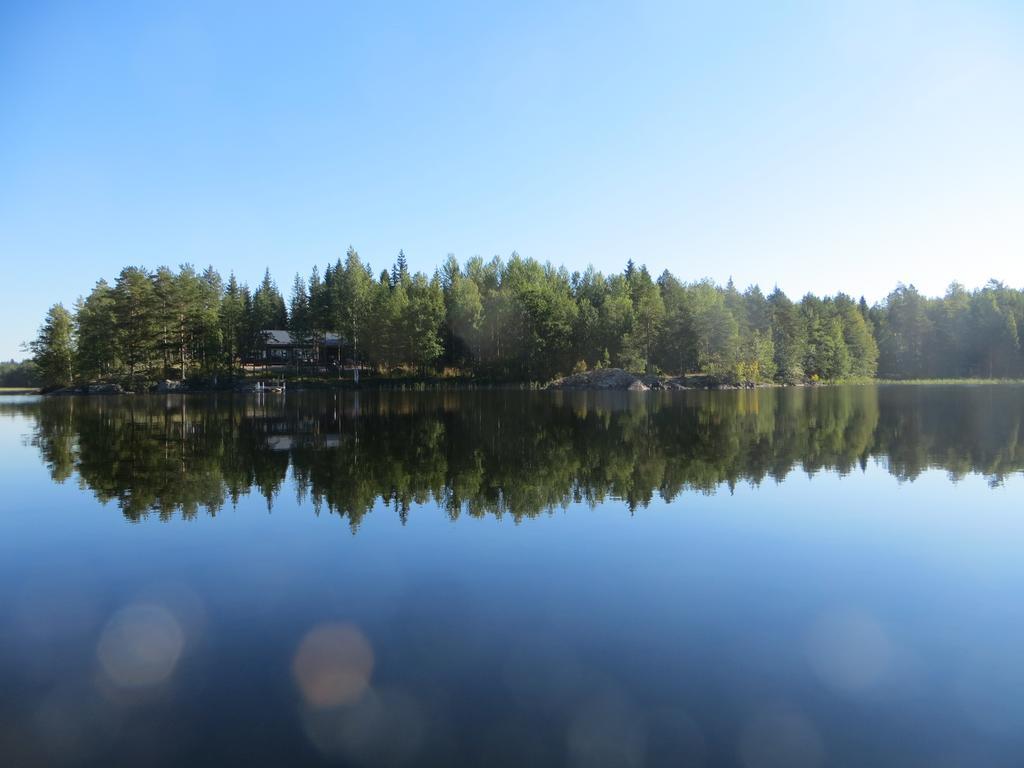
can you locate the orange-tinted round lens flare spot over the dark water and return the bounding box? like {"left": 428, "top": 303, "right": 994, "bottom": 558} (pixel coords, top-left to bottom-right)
{"left": 292, "top": 624, "right": 374, "bottom": 709}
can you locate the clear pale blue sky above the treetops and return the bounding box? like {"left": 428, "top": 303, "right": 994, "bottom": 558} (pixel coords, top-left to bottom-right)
{"left": 0, "top": 0, "right": 1024, "bottom": 358}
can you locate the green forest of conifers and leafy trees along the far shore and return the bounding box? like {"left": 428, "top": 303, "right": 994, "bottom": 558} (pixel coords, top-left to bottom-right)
{"left": 30, "top": 248, "right": 1024, "bottom": 387}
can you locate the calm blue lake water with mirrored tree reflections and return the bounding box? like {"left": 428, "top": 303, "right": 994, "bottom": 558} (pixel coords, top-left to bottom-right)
{"left": 0, "top": 385, "right": 1024, "bottom": 768}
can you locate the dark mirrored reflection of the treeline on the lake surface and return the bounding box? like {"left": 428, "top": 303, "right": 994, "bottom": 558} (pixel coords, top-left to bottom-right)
{"left": 9, "top": 386, "right": 1024, "bottom": 529}
